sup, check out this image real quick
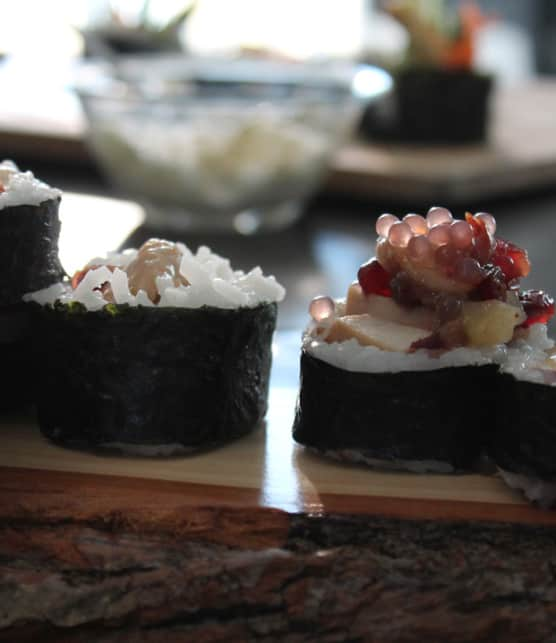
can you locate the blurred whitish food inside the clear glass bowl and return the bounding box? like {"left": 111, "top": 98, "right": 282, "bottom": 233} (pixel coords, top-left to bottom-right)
{"left": 92, "top": 104, "right": 335, "bottom": 210}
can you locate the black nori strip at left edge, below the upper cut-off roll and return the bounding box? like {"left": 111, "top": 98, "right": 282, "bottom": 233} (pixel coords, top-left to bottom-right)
{"left": 0, "top": 304, "right": 35, "bottom": 412}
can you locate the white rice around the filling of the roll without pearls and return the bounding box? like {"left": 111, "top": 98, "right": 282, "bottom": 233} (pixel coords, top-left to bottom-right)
{"left": 23, "top": 243, "right": 286, "bottom": 311}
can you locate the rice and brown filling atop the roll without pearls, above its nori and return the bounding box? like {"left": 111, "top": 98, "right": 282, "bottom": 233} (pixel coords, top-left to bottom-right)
{"left": 28, "top": 239, "right": 285, "bottom": 311}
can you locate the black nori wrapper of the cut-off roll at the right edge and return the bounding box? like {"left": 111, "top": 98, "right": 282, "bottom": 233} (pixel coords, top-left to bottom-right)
{"left": 488, "top": 373, "right": 556, "bottom": 481}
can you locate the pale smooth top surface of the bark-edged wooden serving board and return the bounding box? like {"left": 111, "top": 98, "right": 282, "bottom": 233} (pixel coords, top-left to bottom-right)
{"left": 0, "top": 332, "right": 556, "bottom": 524}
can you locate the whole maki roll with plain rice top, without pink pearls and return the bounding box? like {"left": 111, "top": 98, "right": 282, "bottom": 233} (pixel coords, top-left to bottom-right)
{"left": 26, "top": 239, "right": 284, "bottom": 455}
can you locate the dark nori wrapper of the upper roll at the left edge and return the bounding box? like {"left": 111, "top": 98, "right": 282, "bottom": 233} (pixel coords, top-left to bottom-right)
{"left": 0, "top": 199, "right": 64, "bottom": 306}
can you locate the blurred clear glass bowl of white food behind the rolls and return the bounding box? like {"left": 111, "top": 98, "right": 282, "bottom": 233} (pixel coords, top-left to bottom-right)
{"left": 78, "top": 58, "right": 390, "bottom": 234}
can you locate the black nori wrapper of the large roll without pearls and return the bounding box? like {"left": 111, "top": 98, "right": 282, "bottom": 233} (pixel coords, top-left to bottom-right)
{"left": 32, "top": 303, "right": 277, "bottom": 449}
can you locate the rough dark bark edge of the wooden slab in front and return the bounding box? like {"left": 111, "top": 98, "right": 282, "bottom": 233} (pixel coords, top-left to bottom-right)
{"left": 0, "top": 467, "right": 556, "bottom": 643}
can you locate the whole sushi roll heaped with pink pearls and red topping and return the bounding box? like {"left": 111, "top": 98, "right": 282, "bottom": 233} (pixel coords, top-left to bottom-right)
{"left": 293, "top": 207, "right": 530, "bottom": 473}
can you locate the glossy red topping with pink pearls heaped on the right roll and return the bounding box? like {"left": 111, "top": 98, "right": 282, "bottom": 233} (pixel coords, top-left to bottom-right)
{"left": 348, "top": 206, "right": 554, "bottom": 348}
